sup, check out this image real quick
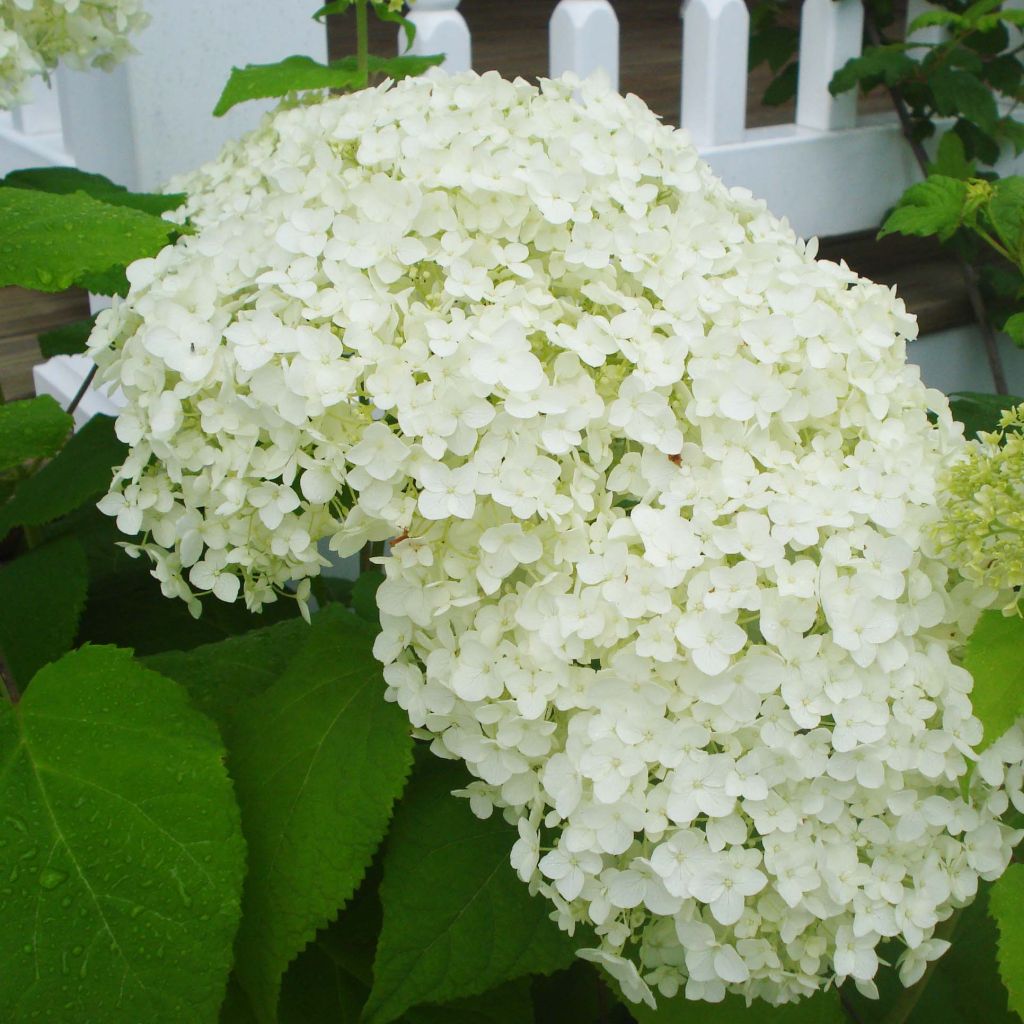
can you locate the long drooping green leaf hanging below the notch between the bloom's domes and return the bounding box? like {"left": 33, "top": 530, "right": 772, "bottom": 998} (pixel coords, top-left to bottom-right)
{"left": 228, "top": 607, "right": 412, "bottom": 1021}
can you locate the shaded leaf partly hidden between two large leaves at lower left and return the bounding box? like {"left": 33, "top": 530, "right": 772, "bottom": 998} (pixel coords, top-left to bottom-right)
{"left": 145, "top": 599, "right": 310, "bottom": 735}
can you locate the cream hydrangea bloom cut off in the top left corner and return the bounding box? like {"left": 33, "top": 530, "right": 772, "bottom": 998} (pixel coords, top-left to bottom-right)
{"left": 0, "top": 0, "right": 148, "bottom": 110}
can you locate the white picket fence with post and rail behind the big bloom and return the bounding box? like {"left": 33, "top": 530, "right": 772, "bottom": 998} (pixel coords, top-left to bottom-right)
{"left": 0, "top": 0, "right": 1015, "bottom": 236}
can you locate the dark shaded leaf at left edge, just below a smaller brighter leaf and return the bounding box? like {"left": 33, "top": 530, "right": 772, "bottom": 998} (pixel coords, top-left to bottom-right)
{"left": 0, "top": 416, "right": 125, "bottom": 537}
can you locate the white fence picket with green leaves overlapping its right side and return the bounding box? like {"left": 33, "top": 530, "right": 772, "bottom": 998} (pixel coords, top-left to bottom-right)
{"left": 797, "top": 0, "right": 864, "bottom": 131}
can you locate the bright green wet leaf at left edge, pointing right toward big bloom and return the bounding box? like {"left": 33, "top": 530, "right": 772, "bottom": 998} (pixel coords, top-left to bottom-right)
{"left": 0, "top": 187, "right": 180, "bottom": 292}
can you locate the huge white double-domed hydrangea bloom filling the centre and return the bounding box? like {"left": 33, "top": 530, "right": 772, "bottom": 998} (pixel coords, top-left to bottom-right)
{"left": 91, "top": 75, "right": 1024, "bottom": 1002}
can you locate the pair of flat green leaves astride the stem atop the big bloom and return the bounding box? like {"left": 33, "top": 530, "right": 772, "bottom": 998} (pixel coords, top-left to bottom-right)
{"left": 213, "top": 53, "right": 444, "bottom": 118}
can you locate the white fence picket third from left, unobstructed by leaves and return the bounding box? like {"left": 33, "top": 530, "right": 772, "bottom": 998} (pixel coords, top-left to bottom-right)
{"left": 682, "top": 0, "right": 749, "bottom": 147}
